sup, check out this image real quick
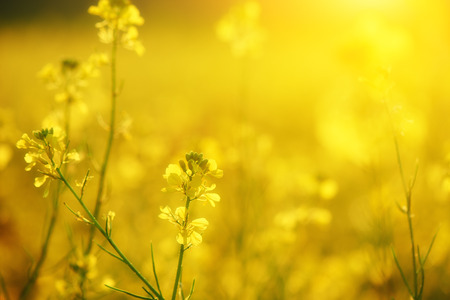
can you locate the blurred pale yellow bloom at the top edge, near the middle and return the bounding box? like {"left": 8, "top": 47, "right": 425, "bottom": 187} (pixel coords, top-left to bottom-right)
{"left": 216, "top": 1, "right": 264, "bottom": 57}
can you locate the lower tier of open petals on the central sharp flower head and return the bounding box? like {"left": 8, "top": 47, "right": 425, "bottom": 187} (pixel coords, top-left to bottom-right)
{"left": 159, "top": 206, "right": 209, "bottom": 247}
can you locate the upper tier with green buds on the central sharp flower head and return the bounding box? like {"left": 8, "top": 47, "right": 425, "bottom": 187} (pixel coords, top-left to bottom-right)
{"left": 162, "top": 152, "right": 223, "bottom": 207}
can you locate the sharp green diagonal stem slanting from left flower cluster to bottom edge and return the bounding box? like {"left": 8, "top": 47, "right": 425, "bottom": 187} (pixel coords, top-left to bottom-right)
{"left": 56, "top": 168, "right": 164, "bottom": 300}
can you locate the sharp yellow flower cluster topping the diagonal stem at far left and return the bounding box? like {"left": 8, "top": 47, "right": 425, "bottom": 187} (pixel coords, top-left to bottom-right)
{"left": 16, "top": 127, "right": 80, "bottom": 197}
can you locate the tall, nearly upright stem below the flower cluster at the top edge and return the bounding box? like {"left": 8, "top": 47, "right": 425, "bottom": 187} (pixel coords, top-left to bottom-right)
{"left": 85, "top": 29, "right": 118, "bottom": 254}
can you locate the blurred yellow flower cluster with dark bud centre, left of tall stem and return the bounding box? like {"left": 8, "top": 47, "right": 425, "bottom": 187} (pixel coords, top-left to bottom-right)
{"left": 38, "top": 53, "right": 108, "bottom": 108}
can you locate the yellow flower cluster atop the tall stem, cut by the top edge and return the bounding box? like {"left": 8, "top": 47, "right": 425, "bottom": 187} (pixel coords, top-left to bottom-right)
{"left": 88, "top": 0, "right": 145, "bottom": 55}
